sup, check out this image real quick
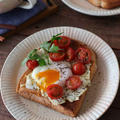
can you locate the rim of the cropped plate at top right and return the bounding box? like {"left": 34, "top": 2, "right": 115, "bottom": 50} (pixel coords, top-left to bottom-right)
{"left": 61, "top": 0, "right": 120, "bottom": 17}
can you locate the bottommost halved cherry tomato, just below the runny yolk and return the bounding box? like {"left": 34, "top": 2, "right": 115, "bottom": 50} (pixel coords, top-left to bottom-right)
{"left": 46, "top": 84, "right": 63, "bottom": 99}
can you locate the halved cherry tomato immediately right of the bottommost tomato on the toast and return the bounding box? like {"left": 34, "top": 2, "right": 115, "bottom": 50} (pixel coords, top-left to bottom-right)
{"left": 65, "top": 75, "right": 82, "bottom": 90}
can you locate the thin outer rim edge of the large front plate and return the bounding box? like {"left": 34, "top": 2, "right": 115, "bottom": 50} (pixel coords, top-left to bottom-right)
{"left": 0, "top": 26, "right": 120, "bottom": 119}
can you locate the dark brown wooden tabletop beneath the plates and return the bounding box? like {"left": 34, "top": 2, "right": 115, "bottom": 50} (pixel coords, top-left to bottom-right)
{"left": 0, "top": 0, "right": 120, "bottom": 120}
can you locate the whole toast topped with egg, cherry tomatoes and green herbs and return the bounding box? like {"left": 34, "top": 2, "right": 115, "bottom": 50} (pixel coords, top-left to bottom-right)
{"left": 16, "top": 33, "right": 97, "bottom": 117}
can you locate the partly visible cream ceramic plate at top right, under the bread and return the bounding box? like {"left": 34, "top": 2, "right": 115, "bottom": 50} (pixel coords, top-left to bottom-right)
{"left": 62, "top": 0, "right": 120, "bottom": 16}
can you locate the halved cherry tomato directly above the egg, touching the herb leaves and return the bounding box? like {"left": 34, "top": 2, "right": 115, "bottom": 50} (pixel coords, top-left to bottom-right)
{"left": 49, "top": 52, "right": 65, "bottom": 61}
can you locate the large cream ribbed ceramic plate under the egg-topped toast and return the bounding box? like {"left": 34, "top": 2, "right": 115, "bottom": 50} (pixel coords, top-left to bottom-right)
{"left": 1, "top": 27, "right": 119, "bottom": 120}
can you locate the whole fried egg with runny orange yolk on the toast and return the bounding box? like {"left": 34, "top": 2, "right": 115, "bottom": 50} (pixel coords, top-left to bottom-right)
{"left": 26, "top": 61, "right": 72, "bottom": 91}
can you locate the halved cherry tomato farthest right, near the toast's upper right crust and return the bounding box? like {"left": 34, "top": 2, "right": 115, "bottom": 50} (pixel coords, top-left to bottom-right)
{"left": 76, "top": 47, "right": 91, "bottom": 64}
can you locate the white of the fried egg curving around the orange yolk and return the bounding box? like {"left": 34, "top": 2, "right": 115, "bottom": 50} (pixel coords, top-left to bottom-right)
{"left": 26, "top": 61, "right": 72, "bottom": 89}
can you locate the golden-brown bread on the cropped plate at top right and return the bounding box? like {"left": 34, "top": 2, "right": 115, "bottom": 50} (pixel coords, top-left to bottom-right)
{"left": 88, "top": 0, "right": 120, "bottom": 9}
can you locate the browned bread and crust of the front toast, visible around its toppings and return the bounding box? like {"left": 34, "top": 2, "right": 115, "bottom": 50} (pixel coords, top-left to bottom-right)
{"left": 16, "top": 41, "right": 97, "bottom": 117}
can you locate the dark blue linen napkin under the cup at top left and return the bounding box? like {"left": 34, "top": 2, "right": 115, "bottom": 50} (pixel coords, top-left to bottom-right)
{"left": 0, "top": 0, "right": 47, "bottom": 35}
